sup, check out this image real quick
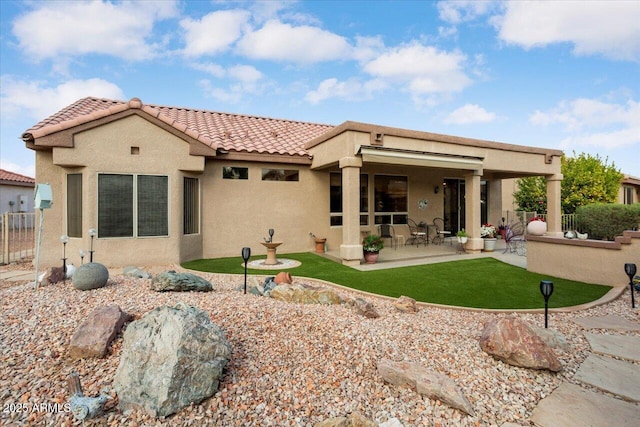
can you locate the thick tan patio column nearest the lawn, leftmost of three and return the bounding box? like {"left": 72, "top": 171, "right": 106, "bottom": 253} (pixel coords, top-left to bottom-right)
{"left": 340, "top": 157, "right": 362, "bottom": 265}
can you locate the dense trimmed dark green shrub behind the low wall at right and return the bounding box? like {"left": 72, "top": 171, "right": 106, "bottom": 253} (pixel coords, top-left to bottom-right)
{"left": 576, "top": 203, "right": 640, "bottom": 240}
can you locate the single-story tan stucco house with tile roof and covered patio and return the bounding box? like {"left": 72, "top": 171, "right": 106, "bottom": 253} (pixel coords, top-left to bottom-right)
{"left": 22, "top": 98, "right": 562, "bottom": 267}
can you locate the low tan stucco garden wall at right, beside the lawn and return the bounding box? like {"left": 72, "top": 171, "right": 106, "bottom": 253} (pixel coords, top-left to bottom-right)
{"left": 527, "top": 231, "right": 640, "bottom": 286}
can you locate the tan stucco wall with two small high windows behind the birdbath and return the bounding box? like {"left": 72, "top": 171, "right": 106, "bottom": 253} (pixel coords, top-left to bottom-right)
{"left": 202, "top": 161, "right": 336, "bottom": 258}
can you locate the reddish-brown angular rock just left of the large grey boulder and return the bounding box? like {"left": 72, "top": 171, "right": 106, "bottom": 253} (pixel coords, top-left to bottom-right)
{"left": 69, "top": 305, "right": 129, "bottom": 359}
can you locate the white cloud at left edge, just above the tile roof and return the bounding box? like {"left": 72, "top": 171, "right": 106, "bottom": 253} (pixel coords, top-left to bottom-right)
{"left": 0, "top": 76, "right": 124, "bottom": 121}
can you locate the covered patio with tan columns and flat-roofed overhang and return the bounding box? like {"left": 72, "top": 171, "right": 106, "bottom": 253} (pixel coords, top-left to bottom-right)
{"left": 305, "top": 122, "right": 562, "bottom": 267}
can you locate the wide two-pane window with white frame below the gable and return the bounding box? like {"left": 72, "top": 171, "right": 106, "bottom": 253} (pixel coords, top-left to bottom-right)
{"left": 98, "top": 173, "right": 169, "bottom": 237}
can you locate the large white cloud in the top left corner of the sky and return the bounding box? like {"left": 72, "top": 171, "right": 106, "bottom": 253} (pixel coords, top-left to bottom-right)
{"left": 13, "top": 1, "right": 177, "bottom": 61}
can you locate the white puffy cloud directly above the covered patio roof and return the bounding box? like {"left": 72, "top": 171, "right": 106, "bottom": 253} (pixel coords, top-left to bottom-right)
{"left": 364, "top": 43, "right": 471, "bottom": 95}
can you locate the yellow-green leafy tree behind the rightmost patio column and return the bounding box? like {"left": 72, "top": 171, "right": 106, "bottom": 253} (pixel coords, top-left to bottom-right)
{"left": 513, "top": 153, "right": 623, "bottom": 214}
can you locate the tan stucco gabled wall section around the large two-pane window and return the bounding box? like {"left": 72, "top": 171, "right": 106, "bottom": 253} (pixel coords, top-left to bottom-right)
{"left": 36, "top": 116, "right": 204, "bottom": 267}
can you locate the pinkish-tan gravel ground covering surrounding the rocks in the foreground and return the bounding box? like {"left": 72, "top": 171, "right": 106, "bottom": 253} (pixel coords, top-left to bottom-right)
{"left": 0, "top": 267, "right": 640, "bottom": 427}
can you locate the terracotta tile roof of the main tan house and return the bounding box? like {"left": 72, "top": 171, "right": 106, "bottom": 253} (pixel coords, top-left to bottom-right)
{"left": 22, "top": 97, "right": 333, "bottom": 156}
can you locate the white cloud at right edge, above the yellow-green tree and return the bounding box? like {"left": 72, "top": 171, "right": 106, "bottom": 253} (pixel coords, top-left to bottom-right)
{"left": 529, "top": 98, "right": 640, "bottom": 149}
